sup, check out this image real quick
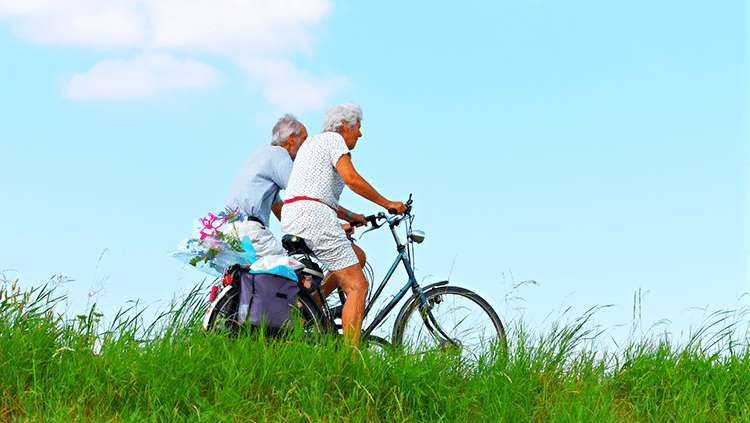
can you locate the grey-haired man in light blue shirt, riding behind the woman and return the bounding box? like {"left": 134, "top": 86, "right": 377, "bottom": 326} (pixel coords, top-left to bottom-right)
{"left": 225, "top": 114, "right": 307, "bottom": 258}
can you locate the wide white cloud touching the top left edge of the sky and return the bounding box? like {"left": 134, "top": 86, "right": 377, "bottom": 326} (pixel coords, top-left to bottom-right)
{"left": 0, "top": 0, "right": 332, "bottom": 54}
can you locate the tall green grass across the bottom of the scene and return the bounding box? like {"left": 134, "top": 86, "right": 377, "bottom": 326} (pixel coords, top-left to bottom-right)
{"left": 0, "top": 283, "right": 750, "bottom": 422}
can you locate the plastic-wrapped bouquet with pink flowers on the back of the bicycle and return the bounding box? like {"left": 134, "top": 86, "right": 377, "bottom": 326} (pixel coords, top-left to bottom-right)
{"left": 170, "top": 207, "right": 257, "bottom": 277}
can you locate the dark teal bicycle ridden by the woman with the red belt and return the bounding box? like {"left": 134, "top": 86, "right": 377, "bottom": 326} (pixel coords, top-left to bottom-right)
{"left": 204, "top": 196, "right": 506, "bottom": 360}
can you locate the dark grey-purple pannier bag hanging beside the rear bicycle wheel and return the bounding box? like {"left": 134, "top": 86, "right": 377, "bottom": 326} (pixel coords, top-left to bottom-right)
{"left": 231, "top": 265, "right": 299, "bottom": 328}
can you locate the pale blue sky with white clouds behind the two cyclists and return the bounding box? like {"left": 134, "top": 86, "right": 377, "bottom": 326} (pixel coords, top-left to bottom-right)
{"left": 0, "top": 0, "right": 750, "bottom": 348}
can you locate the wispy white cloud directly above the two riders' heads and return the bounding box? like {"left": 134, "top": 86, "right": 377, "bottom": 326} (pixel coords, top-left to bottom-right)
{"left": 238, "top": 59, "right": 352, "bottom": 113}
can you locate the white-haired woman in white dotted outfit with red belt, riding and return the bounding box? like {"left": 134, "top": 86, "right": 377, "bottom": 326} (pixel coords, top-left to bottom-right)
{"left": 281, "top": 103, "right": 406, "bottom": 346}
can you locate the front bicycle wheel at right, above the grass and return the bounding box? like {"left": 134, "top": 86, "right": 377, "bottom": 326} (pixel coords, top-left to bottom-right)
{"left": 393, "top": 286, "right": 507, "bottom": 363}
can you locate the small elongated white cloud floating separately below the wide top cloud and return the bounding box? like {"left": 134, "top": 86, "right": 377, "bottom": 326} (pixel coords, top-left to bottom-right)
{"left": 63, "top": 53, "right": 223, "bottom": 100}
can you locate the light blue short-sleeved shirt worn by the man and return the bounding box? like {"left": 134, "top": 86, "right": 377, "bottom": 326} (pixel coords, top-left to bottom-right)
{"left": 225, "top": 144, "right": 294, "bottom": 226}
